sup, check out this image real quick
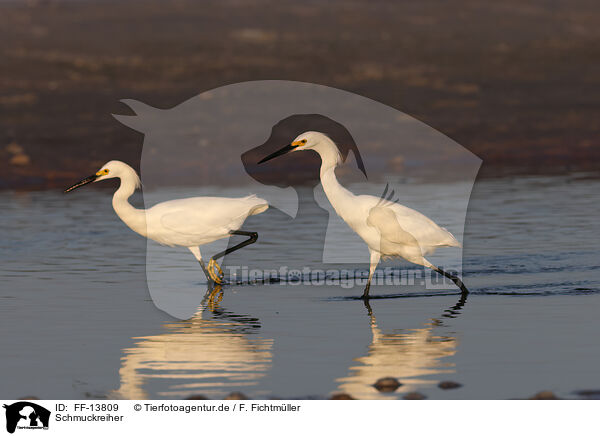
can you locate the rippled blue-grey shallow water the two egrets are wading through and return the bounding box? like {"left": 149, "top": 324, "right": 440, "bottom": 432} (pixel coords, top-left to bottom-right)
{"left": 0, "top": 174, "right": 600, "bottom": 399}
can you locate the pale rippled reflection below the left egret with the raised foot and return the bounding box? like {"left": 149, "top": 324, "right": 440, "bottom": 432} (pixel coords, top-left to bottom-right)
{"left": 112, "top": 286, "right": 273, "bottom": 399}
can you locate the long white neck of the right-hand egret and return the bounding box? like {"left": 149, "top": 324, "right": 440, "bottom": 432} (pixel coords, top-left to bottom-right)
{"left": 313, "top": 138, "right": 354, "bottom": 216}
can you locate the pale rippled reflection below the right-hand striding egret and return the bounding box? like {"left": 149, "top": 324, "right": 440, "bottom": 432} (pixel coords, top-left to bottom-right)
{"left": 336, "top": 293, "right": 467, "bottom": 400}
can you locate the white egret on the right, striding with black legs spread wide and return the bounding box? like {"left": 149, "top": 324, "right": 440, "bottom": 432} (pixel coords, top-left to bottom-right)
{"left": 259, "top": 132, "right": 469, "bottom": 299}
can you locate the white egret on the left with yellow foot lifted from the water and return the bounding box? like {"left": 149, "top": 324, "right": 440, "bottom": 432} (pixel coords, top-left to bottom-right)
{"left": 65, "top": 160, "right": 269, "bottom": 283}
